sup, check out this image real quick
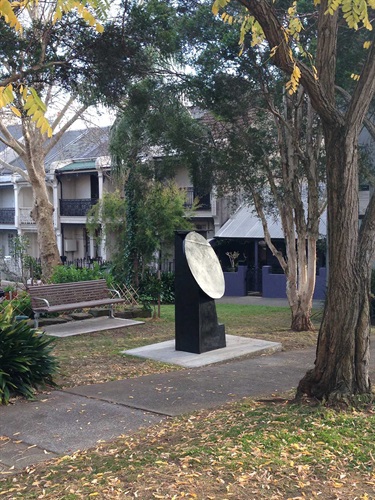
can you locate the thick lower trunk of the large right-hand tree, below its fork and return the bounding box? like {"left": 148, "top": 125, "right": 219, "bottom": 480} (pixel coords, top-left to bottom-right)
{"left": 297, "top": 124, "right": 371, "bottom": 401}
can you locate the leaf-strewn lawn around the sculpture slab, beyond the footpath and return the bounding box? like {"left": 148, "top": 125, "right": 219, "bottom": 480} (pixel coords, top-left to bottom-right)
{"left": 54, "top": 304, "right": 316, "bottom": 387}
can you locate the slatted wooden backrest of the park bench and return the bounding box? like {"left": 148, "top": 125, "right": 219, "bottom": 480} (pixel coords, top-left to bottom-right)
{"left": 28, "top": 280, "right": 109, "bottom": 307}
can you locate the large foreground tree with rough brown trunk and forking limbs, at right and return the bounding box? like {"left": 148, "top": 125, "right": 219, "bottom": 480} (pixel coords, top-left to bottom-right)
{"left": 234, "top": 0, "right": 375, "bottom": 400}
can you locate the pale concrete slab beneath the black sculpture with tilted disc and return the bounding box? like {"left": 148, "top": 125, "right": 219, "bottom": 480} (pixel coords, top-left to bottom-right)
{"left": 123, "top": 335, "right": 282, "bottom": 368}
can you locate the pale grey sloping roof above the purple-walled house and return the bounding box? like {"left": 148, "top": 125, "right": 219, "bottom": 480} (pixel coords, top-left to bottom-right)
{"left": 215, "top": 206, "right": 327, "bottom": 239}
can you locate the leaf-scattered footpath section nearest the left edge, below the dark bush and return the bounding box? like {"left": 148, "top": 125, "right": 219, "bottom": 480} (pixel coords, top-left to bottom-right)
{"left": 0, "top": 391, "right": 165, "bottom": 465}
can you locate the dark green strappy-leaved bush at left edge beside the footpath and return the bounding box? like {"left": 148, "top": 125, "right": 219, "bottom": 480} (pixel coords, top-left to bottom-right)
{"left": 0, "top": 305, "right": 58, "bottom": 404}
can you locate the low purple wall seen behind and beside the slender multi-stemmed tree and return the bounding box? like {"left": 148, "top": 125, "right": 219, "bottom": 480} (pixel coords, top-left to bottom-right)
{"left": 262, "top": 266, "right": 327, "bottom": 300}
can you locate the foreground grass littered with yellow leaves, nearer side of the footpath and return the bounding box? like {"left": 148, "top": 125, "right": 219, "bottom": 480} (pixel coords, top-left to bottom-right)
{"left": 0, "top": 400, "right": 375, "bottom": 500}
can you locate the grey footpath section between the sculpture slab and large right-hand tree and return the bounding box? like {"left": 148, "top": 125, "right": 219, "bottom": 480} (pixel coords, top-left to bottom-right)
{"left": 68, "top": 348, "right": 315, "bottom": 416}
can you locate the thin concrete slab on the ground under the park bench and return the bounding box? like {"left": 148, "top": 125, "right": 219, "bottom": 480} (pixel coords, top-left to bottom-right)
{"left": 42, "top": 316, "right": 143, "bottom": 337}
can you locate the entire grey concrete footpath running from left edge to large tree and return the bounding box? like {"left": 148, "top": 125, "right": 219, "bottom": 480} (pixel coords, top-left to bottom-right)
{"left": 0, "top": 349, "right": 315, "bottom": 474}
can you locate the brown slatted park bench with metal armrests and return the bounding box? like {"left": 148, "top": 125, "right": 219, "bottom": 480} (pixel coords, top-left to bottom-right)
{"left": 27, "top": 279, "right": 125, "bottom": 328}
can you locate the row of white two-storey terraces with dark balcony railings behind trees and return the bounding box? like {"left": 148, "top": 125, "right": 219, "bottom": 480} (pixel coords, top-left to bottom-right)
{"left": 0, "top": 127, "right": 234, "bottom": 268}
